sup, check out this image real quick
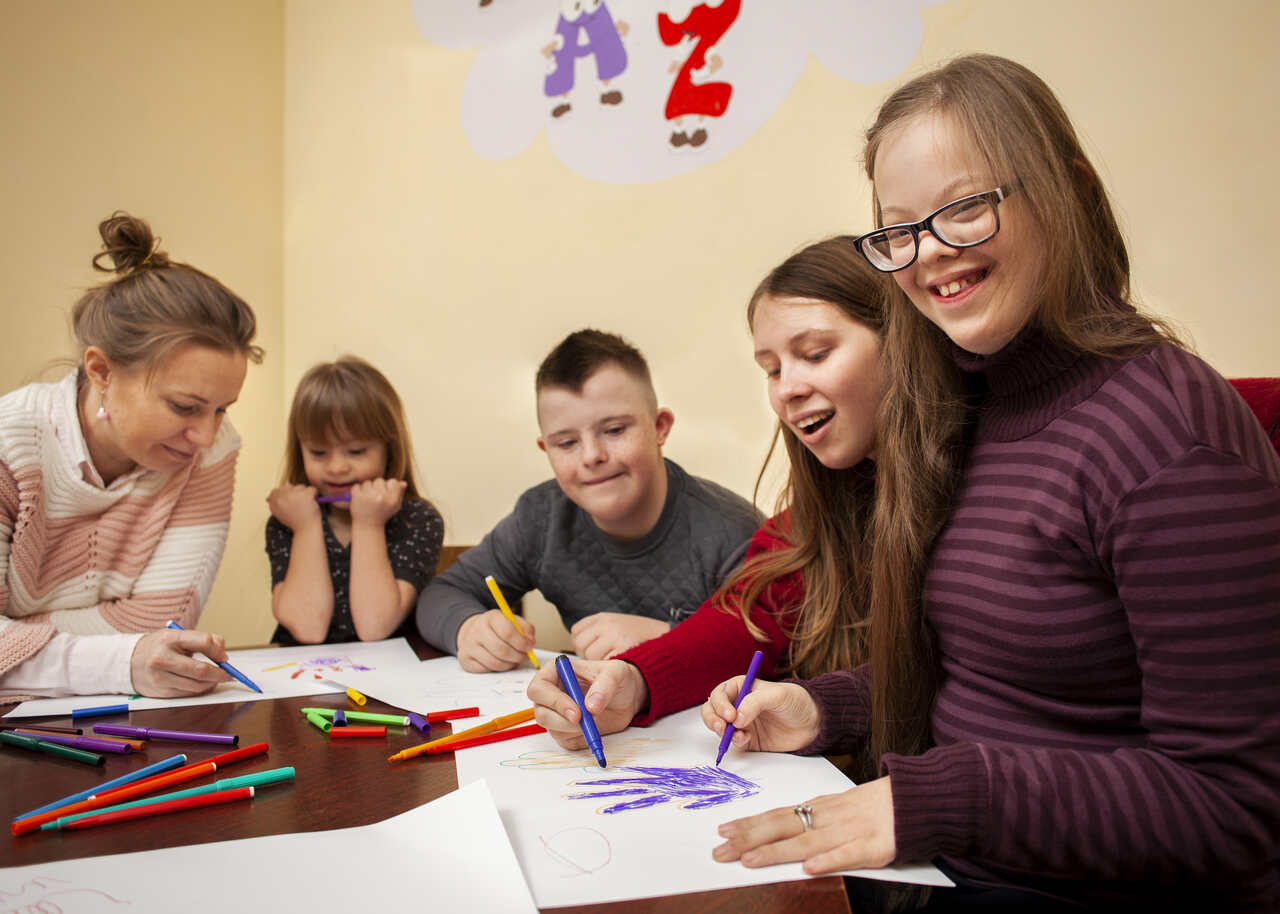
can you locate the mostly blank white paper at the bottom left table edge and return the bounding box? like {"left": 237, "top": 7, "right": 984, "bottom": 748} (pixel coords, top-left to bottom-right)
{"left": 0, "top": 781, "right": 538, "bottom": 914}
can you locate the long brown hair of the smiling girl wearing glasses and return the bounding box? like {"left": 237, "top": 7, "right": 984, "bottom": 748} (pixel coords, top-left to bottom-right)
{"left": 864, "top": 54, "right": 1178, "bottom": 757}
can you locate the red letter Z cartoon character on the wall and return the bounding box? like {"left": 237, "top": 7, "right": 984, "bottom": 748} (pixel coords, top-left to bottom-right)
{"left": 658, "top": 0, "right": 742, "bottom": 148}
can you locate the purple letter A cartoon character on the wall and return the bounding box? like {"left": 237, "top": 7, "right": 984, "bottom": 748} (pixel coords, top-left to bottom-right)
{"left": 543, "top": 0, "right": 627, "bottom": 118}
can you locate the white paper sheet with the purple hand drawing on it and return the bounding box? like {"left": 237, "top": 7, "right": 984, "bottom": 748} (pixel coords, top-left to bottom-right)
{"left": 457, "top": 708, "right": 951, "bottom": 908}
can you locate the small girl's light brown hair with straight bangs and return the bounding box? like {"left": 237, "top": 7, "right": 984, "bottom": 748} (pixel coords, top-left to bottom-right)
{"left": 282, "top": 356, "right": 422, "bottom": 499}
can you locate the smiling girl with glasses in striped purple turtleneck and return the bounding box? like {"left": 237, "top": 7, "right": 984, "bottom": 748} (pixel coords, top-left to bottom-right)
{"left": 704, "top": 55, "right": 1280, "bottom": 911}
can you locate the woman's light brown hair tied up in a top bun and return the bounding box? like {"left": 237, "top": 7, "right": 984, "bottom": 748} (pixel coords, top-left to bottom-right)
{"left": 72, "top": 211, "right": 262, "bottom": 384}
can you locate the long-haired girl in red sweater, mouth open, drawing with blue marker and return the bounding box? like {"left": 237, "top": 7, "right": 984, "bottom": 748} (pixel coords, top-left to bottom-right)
{"left": 529, "top": 236, "right": 887, "bottom": 762}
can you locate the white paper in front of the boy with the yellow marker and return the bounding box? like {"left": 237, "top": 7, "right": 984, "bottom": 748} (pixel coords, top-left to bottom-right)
{"left": 333, "top": 650, "right": 557, "bottom": 716}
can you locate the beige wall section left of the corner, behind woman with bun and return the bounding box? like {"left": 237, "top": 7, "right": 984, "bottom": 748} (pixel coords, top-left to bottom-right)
{"left": 0, "top": 0, "right": 284, "bottom": 643}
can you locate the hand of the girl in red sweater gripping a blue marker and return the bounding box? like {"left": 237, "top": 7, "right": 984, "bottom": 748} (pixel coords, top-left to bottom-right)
{"left": 527, "top": 657, "right": 649, "bottom": 749}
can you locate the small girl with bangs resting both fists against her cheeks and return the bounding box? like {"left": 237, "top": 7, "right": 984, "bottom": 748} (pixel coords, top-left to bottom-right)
{"left": 266, "top": 356, "right": 444, "bottom": 644}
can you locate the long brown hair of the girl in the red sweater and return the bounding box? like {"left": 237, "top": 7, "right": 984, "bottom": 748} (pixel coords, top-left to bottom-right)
{"left": 719, "top": 236, "right": 887, "bottom": 676}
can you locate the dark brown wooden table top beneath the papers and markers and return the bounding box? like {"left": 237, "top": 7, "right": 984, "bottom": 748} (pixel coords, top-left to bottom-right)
{"left": 0, "top": 639, "right": 850, "bottom": 914}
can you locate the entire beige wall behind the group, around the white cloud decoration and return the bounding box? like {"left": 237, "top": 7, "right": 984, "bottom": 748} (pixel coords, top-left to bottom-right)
{"left": 0, "top": 0, "right": 1280, "bottom": 643}
